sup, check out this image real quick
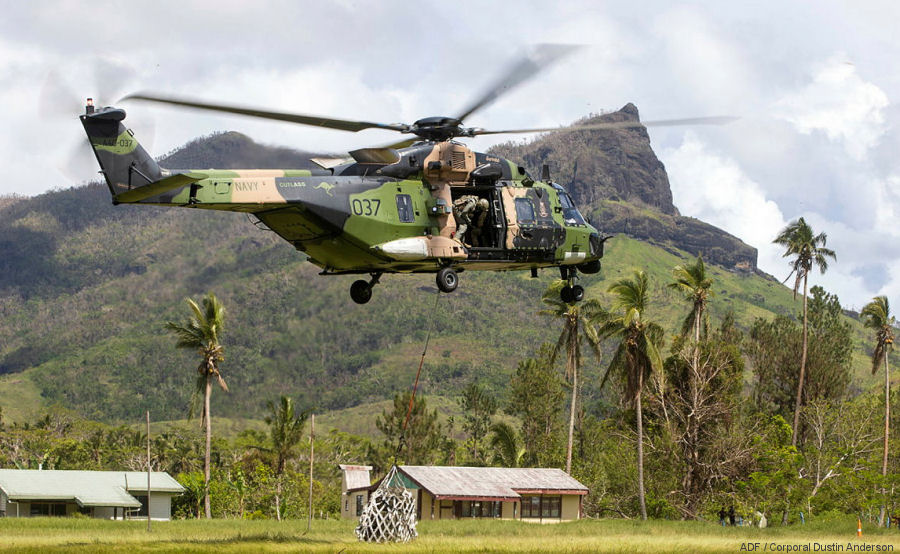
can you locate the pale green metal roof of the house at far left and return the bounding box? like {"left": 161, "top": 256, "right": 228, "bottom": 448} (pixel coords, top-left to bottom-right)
{"left": 0, "top": 469, "right": 184, "bottom": 508}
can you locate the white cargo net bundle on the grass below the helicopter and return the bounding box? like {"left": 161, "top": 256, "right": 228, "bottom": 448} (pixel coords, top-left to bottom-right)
{"left": 356, "top": 466, "right": 418, "bottom": 542}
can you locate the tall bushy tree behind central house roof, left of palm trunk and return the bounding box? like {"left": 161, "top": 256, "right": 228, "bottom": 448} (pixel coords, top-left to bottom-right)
{"left": 506, "top": 344, "right": 566, "bottom": 467}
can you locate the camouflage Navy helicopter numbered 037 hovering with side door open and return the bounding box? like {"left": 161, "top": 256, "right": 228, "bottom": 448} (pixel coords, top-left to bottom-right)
{"left": 80, "top": 45, "right": 728, "bottom": 304}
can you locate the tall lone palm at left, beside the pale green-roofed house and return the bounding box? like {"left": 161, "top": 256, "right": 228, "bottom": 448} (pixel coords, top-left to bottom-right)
{"left": 166, "top": 292, "right": 228, "bottom": 519}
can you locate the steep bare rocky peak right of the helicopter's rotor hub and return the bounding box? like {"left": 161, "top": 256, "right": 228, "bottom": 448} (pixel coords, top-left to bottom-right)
{"left": 491, "top": 104, "right": 760, "bottom": 271}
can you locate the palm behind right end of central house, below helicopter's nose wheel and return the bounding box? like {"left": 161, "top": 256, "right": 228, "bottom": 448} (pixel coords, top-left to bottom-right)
{"left": 539, "top": 280, "right": 603, "bottom": 474}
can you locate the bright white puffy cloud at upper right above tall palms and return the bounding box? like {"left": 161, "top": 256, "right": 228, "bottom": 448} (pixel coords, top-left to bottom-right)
{"left": 775, "top": 54, "right": 889, "bottom": 160}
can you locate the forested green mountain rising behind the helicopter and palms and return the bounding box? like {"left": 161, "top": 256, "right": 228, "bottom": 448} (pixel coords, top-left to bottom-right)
{"left": 0, "top": 114, "right": 880, "bottom": 428}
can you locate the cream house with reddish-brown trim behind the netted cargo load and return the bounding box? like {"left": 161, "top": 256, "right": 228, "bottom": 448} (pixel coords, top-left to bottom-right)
{"left": 341, "top": 465, "right": 588, "bottom": 523}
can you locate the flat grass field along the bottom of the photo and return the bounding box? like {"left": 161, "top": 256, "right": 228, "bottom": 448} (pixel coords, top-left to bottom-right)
{"left": 0, "top": 516, "right": 900, "bottom": 553}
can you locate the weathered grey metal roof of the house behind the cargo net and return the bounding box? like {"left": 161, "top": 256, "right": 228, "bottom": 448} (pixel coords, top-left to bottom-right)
{"left": 399, "top": 466, "right": 588, "bottom": 498}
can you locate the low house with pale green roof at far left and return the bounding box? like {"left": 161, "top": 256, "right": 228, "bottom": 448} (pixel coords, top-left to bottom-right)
{"left": 0, "top": 469, "right": 184, "bottom": 520}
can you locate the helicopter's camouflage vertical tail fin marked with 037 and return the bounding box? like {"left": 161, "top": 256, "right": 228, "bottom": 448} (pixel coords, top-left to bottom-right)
{"left": 81, "top": 99, "right": 163, "bottom": 198}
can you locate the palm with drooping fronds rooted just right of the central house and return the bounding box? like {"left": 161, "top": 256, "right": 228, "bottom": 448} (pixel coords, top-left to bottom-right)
{"left": 598, "top": 271, "right": 663, "bottom": 520}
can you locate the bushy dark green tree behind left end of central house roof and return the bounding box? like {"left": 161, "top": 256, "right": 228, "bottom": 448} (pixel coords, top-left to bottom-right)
{"left": 375, "top": 391, "right": 442, "bottom": 465}
